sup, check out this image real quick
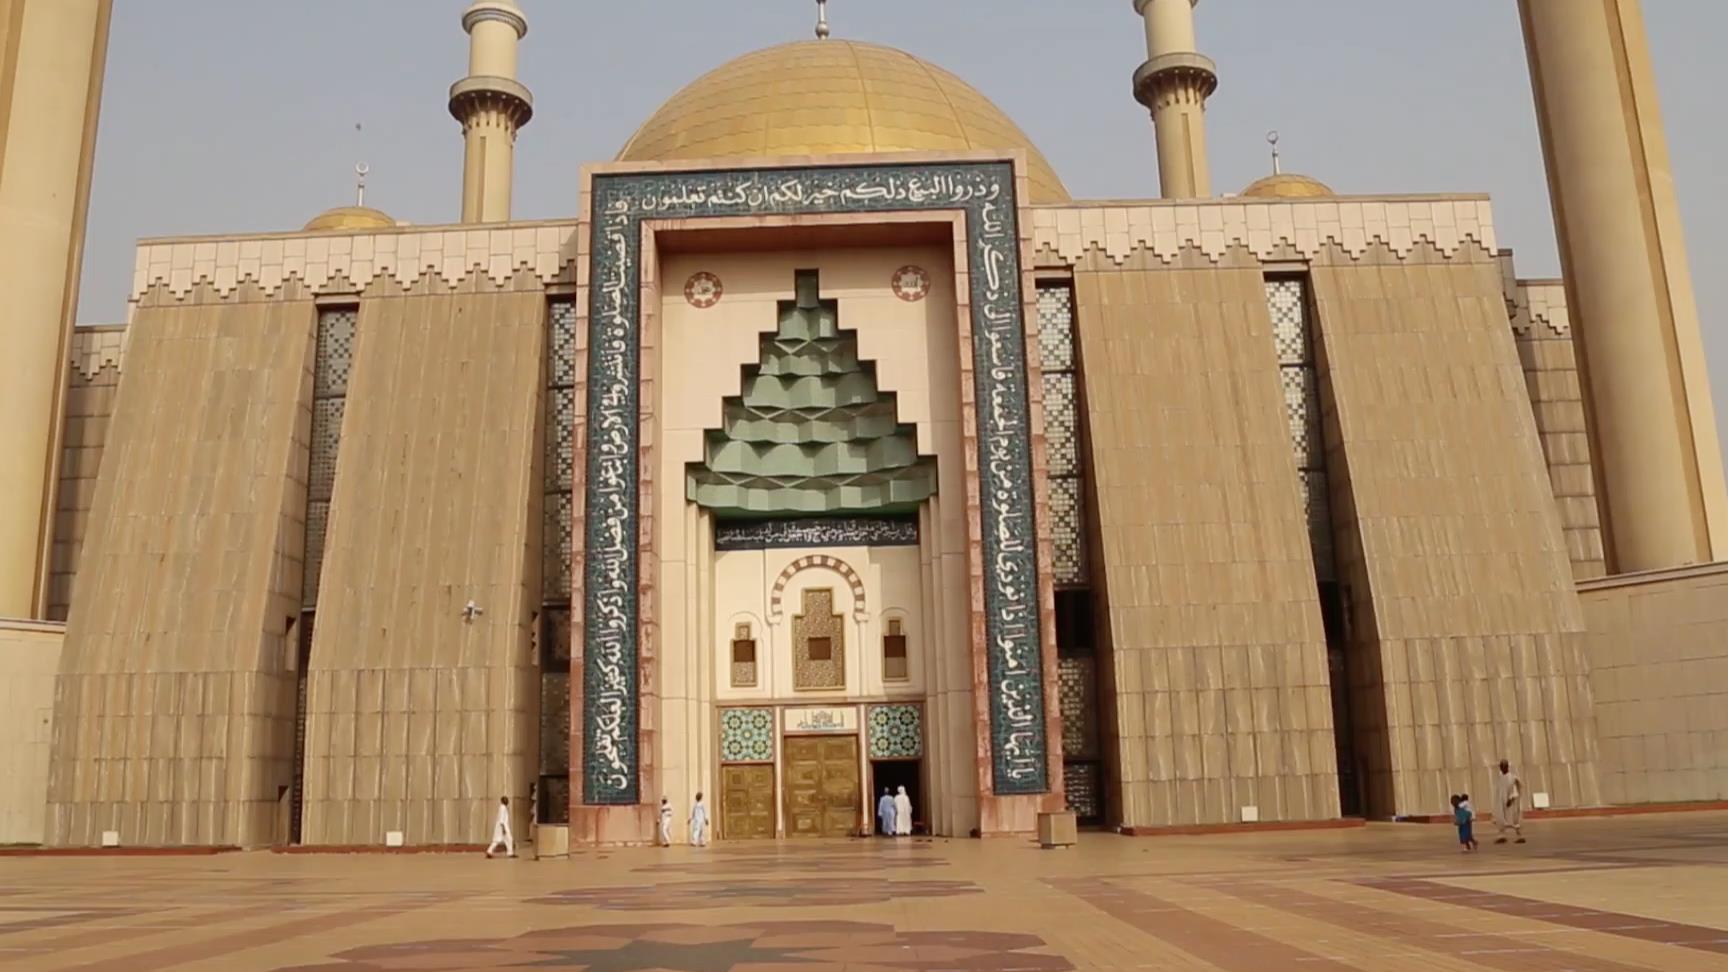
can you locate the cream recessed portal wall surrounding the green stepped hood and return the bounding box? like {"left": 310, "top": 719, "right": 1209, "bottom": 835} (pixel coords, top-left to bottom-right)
{"left": 645, "top": 246, "right": 978, "bottom": 835}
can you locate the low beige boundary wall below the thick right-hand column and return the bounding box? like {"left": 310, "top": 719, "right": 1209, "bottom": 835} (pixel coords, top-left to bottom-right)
{"left": 1579, "top": 564, "right": 1728, "bottom": 804}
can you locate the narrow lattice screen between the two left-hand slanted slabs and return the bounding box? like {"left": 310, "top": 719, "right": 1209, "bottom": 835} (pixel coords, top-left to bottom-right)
{"left": 301, "top": 308, "right": 359, "bottom": 611}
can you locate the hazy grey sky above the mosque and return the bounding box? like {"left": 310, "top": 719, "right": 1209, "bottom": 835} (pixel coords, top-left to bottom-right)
{"left": 79, "top": 0, "right": 1728, "bottom": 453}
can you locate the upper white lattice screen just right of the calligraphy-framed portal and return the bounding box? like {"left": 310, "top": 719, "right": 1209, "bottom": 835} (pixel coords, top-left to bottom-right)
{"left": 1039, "top": 282, "right": 1087, "bottom": 585}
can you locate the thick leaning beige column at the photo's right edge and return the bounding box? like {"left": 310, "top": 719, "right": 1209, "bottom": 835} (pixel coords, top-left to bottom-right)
{"left": 1519, "top": 0, "right": 1728, "bottom": 572}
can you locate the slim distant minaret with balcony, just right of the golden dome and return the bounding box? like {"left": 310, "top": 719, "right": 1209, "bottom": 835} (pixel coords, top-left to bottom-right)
{"left": 1134, "top": 0, "right": 1218, "bottom": 199}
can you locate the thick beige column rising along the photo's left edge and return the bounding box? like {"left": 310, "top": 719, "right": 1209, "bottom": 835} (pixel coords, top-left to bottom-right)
{"left": 0, "top": 0, "right": 112, "bottom": 617}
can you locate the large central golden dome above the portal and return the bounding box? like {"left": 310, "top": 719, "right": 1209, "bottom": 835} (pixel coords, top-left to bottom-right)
{"left": 619, "top": 40, "right": 1068, "bottom": 202}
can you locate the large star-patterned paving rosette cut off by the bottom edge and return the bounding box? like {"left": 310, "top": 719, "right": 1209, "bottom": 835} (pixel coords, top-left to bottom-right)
{"left": 283, "top": 920, "right": 1073, "bottom": 972}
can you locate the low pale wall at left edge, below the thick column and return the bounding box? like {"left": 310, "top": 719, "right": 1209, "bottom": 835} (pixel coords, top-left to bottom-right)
{"left": 0, "top": 621, "right": 66, "bottom": 846}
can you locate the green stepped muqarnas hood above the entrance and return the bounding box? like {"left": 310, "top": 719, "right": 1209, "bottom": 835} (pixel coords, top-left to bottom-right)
{"left": 688, "top": 270, "right": 937, "bottom": 517}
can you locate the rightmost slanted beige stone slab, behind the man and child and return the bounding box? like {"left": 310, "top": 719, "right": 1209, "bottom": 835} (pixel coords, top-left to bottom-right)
{"left": 1312, "top": 246, "right": 1600, "bottom": 815}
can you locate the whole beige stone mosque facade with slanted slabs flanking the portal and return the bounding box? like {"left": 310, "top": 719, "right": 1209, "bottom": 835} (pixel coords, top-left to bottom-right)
{"left": 19, "top": 173, "right": 1728, "bottom": 844}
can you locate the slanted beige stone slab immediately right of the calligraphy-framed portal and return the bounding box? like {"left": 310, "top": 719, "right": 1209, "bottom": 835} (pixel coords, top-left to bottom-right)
{"left": 1075, "top": 254, "right": 1339, "bottom": 827}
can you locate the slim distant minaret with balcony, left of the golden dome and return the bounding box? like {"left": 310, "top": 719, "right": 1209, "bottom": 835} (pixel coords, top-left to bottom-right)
{"left": 449, "top": 0, "right": 534, "bottom": 223}
